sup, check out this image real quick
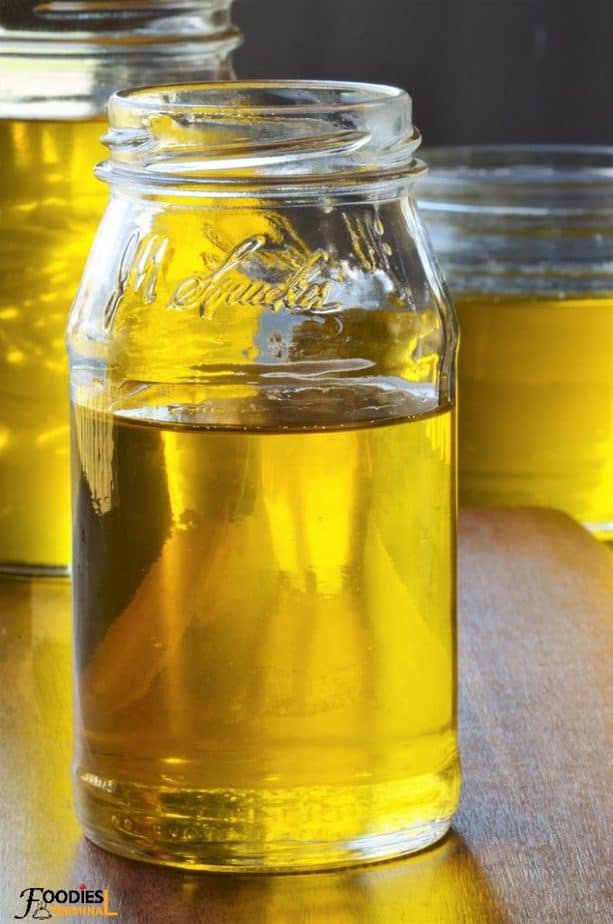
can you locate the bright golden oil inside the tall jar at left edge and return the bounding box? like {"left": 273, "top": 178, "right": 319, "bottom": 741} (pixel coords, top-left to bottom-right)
{"left": 0, "top": 120, "right": 107, "bottom": 568}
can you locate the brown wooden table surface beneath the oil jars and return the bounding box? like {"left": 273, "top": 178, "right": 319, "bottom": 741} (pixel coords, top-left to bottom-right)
{"left": 0, "top": 510, "right": 613, "bottom": 924}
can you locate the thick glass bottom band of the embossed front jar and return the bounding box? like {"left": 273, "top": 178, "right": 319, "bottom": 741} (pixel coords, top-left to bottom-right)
{"left": 76, "top": 759, "right": 459, "bottom": 873}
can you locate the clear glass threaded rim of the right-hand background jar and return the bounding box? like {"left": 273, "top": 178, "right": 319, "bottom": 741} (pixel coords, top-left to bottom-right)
{"left": 419, "top": 144, "right": 613, "bottom": 214}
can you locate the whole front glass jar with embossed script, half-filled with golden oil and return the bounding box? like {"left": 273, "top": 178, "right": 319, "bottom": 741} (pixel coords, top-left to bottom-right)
{"left": 68, "top": 82, "right": 459, "bottom": 870}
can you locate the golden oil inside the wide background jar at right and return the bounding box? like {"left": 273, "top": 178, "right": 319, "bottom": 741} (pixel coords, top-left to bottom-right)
{"left": 456, "top": 288, "right": 613, "bottom": 538}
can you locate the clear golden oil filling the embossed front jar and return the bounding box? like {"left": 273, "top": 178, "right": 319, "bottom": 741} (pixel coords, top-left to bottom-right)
{"left": 73, "top": 398, "right": 459, "bottom": 869}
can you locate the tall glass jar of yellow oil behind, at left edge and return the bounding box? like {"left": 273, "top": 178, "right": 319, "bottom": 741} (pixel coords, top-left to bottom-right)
{"left": 0, "top": 0, "right": 239, "bottom": 574}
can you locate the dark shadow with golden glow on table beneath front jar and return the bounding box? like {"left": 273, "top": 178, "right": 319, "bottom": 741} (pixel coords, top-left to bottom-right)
{"left": 71, "top": 832, "right": 505, "bottom": 924}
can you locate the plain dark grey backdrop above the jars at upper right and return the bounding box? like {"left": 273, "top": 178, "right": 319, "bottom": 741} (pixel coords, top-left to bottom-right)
{"left": 234, "top": 0, "right": 613, "bottom": 145}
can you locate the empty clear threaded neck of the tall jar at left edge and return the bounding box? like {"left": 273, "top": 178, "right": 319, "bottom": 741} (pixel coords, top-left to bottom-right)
{"left": 0, "top": 0, "right": 242, "bottom": 119}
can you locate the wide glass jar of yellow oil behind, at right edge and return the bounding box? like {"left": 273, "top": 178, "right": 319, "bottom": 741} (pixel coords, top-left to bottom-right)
{"left": 419, "top": 146, "right": 613, "bottom": 538}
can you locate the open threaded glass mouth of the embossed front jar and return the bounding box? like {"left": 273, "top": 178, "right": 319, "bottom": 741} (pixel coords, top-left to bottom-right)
{"left": 98, "top": 80, "right": 424, "bottom": 196}
